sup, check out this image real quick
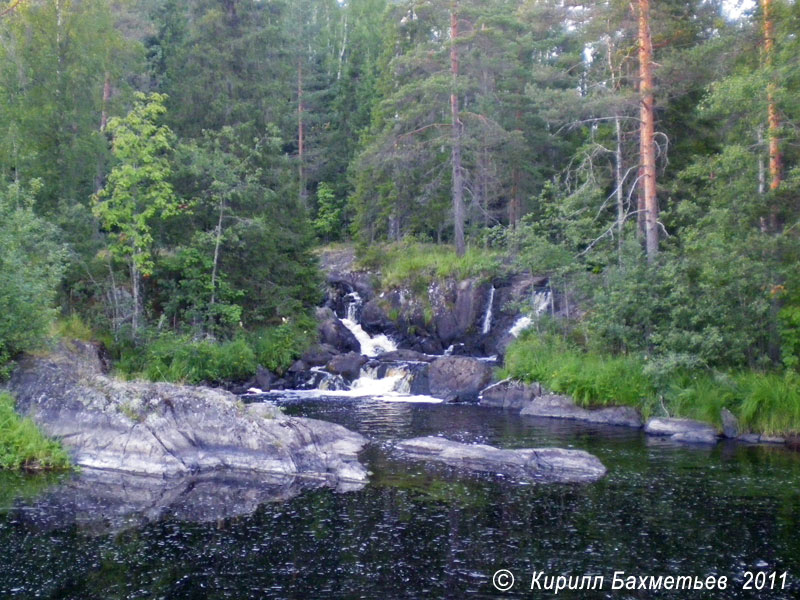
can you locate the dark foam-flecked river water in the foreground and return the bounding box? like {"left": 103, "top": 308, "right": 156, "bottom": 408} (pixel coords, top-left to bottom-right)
{"left": 0, "top": 398, "right": 800, "bottom": 600}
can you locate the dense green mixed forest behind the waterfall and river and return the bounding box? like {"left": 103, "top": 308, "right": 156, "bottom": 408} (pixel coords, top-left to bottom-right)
{"left": 0, "top": 0, "right": 800, "bottom": 429}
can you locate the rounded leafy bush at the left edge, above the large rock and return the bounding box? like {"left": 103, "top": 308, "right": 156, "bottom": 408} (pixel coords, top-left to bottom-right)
{"left": 0, "top": 182, "right": 65, "bottom": 379}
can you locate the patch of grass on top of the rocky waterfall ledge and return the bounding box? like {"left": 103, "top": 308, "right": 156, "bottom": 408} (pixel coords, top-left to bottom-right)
{"left": 358, "top": 242, "right": 503, "bottom": 293}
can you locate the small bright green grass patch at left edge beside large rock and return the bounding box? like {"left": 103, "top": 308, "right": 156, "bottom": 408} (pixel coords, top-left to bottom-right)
{"left": 0, "top": 393, "right": 70, "bottom": 471}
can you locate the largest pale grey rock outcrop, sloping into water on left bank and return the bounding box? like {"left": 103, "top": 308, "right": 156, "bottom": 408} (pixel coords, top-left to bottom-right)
{"left": 9, "top": 345, "right": 367, "bottom": 485}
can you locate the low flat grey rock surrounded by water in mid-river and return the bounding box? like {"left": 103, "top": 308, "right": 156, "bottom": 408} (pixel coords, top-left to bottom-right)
{"left": 395, "top": 437, "right": 606, "bottom": 483}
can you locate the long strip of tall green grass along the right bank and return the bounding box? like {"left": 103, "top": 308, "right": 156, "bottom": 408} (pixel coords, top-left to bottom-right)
{"left": 504, "top": 332, "right": 800, "bottom": 435}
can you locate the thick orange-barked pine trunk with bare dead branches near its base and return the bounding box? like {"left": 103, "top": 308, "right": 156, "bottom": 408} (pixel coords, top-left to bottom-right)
{"left": 639, "top": 0, "right": 658, "bottom": 262}
